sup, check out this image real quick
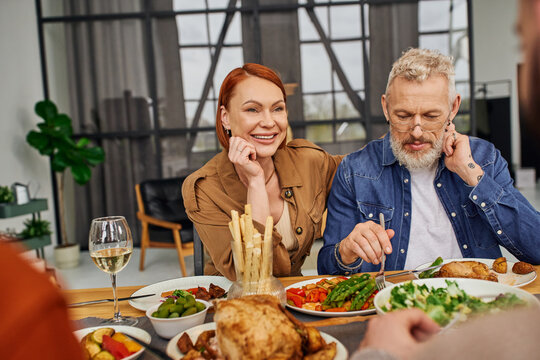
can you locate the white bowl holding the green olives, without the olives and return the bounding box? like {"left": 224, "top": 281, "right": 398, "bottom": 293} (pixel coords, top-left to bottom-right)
{"left": 146, "top": 299, "right": 212, "bottom": 339}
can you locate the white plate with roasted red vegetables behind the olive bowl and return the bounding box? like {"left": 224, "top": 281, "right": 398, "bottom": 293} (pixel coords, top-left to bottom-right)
{"left": 129, "top": 276, "right": 232, "bottom": 311}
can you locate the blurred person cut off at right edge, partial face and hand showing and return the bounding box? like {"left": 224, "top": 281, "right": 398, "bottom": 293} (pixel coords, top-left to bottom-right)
{"left": 351, "top": 0, "right": 540, "bottom": 360}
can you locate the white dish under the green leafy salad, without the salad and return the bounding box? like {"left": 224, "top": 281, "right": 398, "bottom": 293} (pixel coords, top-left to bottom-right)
{"left": 373, "top": 278, "right": 540, "bottom": 314}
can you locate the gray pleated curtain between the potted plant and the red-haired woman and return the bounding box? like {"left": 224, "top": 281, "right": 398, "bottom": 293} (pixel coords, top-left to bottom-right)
{"left": 64, "top": 0, "right": 186, "bottom": 247}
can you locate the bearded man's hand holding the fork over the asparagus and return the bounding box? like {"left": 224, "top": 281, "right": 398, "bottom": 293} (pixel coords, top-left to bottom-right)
{"left": 339, "top": 221, "right": 394, "bottom": 264}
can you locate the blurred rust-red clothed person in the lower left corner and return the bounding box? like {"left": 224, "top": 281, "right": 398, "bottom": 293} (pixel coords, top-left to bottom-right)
{"left": 0, "top": 241, "right": 83, "bottom": 360}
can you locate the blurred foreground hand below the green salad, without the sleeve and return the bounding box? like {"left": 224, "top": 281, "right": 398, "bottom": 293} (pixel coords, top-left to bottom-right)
{"left": 359, "top": 309, "right": 440, "bottom": 359}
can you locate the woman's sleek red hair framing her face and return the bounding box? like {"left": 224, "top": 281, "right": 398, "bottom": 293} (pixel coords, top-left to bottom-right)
{"left": 216, "top": 63, "right": 287, "bottom": 150}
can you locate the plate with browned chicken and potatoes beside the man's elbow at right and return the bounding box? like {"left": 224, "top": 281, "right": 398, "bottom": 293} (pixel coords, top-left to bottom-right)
{"left": 415, "top": 257, "right": 536, "bottom": 287}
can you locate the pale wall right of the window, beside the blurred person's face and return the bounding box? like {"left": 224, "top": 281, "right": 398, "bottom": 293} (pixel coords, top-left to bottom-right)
{"left": 472, "top": 0, "right": 521, "bottom": 165}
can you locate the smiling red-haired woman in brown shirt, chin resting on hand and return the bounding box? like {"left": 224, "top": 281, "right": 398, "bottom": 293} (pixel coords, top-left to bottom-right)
{"left": 182, "top": 64, "right": 342, "bottom": 279}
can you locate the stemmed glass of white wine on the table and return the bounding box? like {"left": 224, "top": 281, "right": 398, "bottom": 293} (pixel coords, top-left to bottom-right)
{"left": 88, "top": 216, "right": 137, "bottom": 325}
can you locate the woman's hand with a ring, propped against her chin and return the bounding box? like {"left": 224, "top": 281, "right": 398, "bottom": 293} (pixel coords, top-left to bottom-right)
{"left": 229, "top": 136, "right": 264, "bottom": 186}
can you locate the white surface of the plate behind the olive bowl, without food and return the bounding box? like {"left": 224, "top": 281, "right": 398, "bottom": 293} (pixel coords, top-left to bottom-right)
{"left": 129, "top": 276, "right": 232, "bottom": 311}
